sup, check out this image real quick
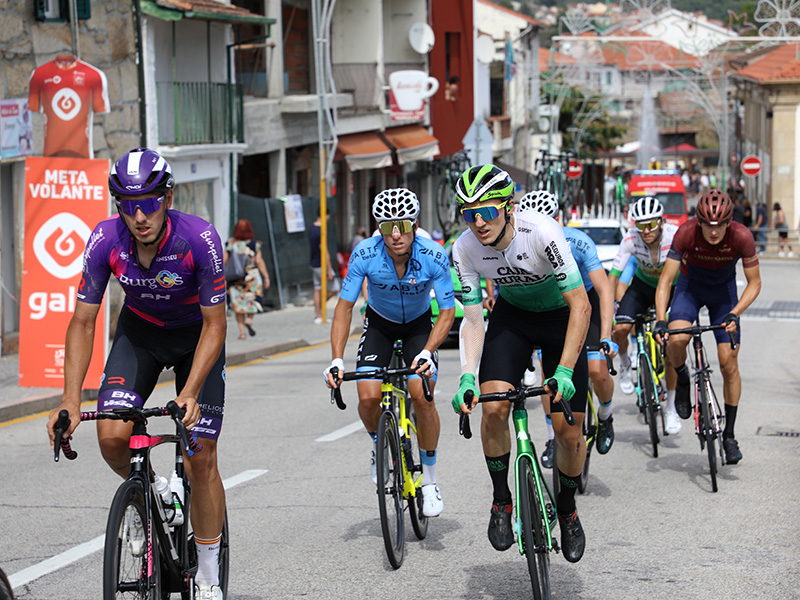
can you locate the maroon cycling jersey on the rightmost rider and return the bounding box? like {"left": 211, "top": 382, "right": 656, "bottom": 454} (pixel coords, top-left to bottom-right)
{"left": 667, "top": 218, "right": 758, "bottom": 284}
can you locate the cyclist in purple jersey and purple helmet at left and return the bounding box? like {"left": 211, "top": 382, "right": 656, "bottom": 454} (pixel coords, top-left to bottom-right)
{"left": 47, "top": 148, "right": 227, "bottom": 600}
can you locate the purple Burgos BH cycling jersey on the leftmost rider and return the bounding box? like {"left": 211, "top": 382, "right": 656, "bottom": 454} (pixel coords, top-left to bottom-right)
{"left": 78, "top": 210, "right": 225, "bottom": 329}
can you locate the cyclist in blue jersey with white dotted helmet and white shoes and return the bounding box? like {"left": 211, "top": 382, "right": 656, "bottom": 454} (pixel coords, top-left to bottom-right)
{"left": 324, "top": 188, "right": 455, "bottom": 517}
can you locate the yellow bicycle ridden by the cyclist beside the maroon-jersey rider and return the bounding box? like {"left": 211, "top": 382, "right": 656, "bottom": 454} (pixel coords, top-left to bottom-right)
{"left": 634, "top": 308, "right": 668, "bottom": 458}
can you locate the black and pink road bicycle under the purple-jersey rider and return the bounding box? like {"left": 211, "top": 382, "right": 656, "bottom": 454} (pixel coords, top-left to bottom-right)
{"left": 54, "top": 401, "right": 230, "bottom": 600}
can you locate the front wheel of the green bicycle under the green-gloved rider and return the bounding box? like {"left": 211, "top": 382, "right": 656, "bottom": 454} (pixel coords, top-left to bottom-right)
{"left": 517, "top": 457, "right": 550, "bottom": 600}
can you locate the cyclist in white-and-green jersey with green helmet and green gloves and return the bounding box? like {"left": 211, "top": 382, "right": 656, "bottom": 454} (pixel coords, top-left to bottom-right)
{"left": 452, "top": 165, "right": 591, "bottom": 562}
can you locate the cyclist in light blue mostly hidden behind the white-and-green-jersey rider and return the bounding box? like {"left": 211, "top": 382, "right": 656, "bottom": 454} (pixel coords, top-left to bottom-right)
{"left": 517, "top": 190, "right": 619, "bottom": 468}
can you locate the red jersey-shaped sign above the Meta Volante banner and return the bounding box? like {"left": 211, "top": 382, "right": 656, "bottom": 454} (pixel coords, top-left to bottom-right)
{"left": 28, "top": 54, "right": 110, "bottom": 158}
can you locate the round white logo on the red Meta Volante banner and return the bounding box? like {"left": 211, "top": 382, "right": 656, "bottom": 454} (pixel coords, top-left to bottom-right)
{"left": 33, "top": 213, "right": 92, "bottom": 279}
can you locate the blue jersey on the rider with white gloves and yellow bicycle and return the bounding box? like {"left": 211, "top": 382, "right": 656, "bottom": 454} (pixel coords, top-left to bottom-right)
{"left": 340, "top": 236, "right": 455, "bottom": 323}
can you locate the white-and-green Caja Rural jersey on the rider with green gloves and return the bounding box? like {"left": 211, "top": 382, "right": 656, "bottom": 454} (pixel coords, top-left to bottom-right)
{"left": 453, "top": 213, "right": 583, "bottom": 312}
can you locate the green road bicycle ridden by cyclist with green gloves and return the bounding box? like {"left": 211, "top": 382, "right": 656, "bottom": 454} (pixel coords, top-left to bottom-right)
{"left": 459, "top": 379, "right": 575, "bottom": 600}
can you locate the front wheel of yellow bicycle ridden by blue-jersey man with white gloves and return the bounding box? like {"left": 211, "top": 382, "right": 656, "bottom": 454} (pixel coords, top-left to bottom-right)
{"left": 375, "top": 411, "right": 405, "bottom": 569}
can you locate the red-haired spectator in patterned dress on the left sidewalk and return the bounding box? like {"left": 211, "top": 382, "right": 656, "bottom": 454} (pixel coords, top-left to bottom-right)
{"left": 223, "top": 219, "right": 269, "bottom": 340}
